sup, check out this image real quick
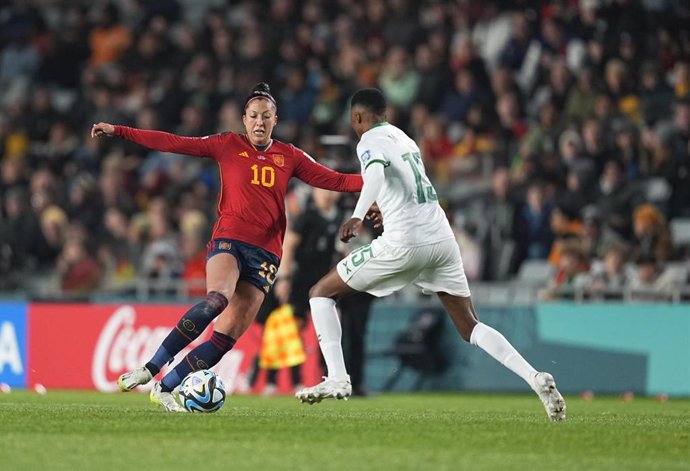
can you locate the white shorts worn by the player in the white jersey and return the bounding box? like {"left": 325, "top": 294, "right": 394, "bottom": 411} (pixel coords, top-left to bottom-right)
{"left": 337, "top": 238, "right": 470, "bottom": 297}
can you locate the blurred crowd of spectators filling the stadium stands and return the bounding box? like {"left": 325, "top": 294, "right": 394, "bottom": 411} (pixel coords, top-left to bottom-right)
{"left": 0, "top": 0, "right": 690, "bottom": 297}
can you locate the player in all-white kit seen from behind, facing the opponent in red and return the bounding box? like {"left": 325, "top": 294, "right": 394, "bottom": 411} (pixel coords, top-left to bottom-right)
{"left": 296, "top": 88, "right": 565, "bottom": 420}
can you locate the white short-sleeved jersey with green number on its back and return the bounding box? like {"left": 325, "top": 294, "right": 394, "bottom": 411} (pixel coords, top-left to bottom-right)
{"left": 357, "top": 123, "right": 455, "bottom": 247}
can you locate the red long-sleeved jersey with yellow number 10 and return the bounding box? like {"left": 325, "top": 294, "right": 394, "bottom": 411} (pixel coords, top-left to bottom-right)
{"left": 115, "top": 126, "right": 362, "bottom": 258}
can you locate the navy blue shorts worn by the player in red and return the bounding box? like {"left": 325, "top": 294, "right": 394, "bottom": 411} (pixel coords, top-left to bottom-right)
{"left": 206, "top": 239, "right": 280, "bottom": 293}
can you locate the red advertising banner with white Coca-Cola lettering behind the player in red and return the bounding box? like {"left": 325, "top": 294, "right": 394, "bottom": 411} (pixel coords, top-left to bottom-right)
{"left": 27, "top": 303, "right": 321, "bottom": 393}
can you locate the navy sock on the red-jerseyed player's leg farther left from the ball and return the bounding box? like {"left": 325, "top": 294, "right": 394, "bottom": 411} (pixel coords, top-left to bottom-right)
{"left": 146, "top": 291, "right": 228, "bottom": 377}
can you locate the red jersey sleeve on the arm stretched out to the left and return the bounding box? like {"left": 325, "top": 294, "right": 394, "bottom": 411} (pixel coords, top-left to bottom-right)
{"left": 115, "top": 126, "right": 224, "bottom": 159}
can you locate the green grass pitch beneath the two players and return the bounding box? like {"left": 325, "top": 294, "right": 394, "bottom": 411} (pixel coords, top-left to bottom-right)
{"left": 0, "top": 391, "right": 690, "bottom": 471}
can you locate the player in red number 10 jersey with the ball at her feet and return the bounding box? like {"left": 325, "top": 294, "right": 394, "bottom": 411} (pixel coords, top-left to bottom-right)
{"left": 91, "top": 83, "right": 362, "bottom": 411}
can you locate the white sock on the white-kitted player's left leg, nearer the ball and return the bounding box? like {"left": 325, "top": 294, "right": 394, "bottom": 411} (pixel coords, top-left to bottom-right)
{"left": 309, "top": 298, "right": 349, "bottom": 381}
